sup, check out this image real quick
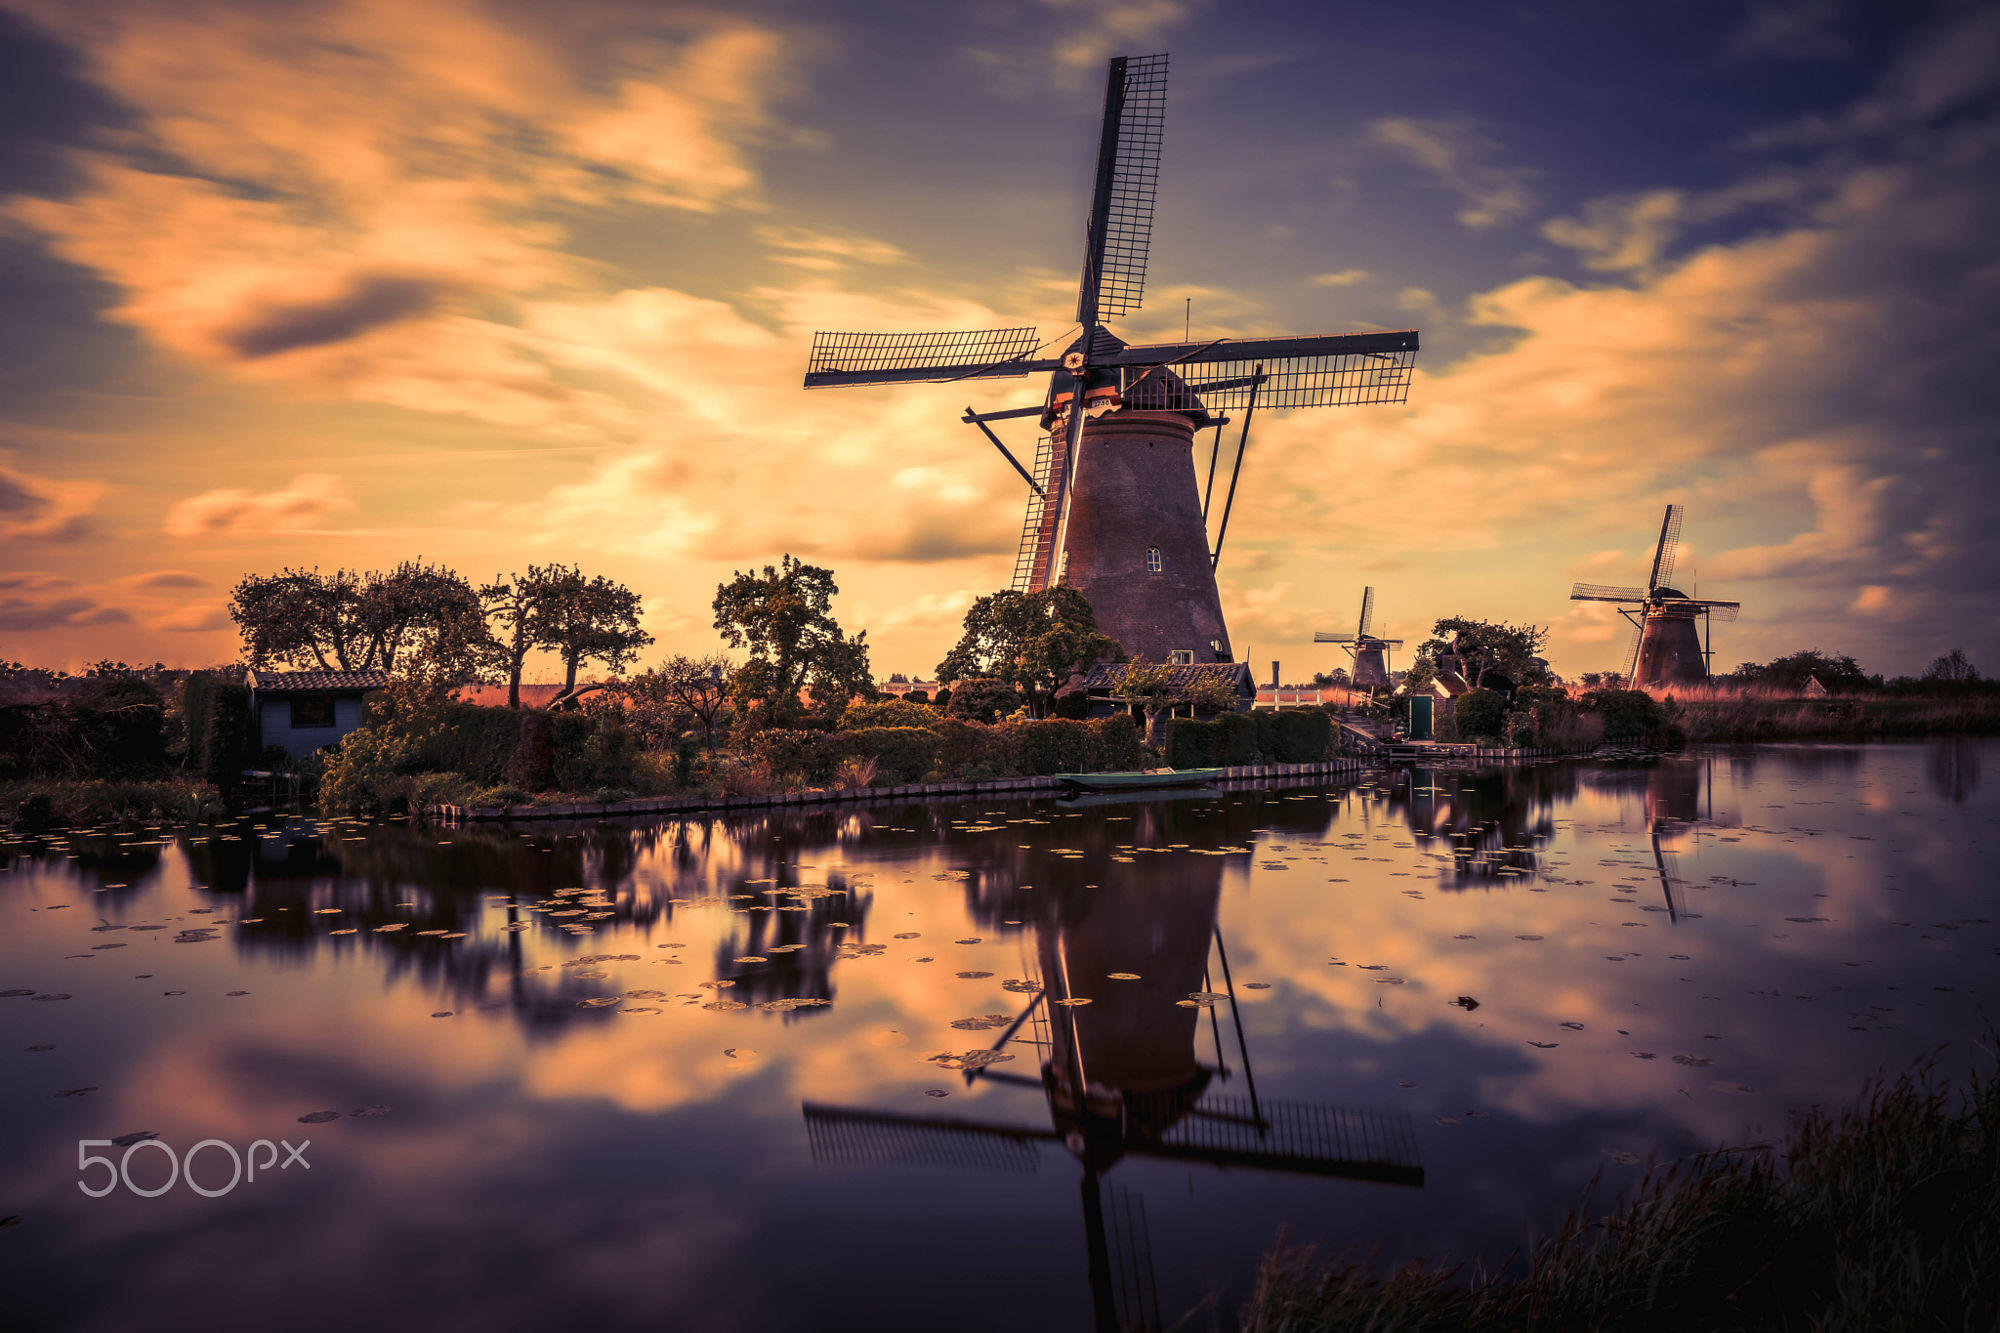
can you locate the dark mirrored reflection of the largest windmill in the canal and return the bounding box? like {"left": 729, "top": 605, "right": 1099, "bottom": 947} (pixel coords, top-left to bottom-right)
{"left": 802, "top": 820, "right": 1424, "bottom": 1329}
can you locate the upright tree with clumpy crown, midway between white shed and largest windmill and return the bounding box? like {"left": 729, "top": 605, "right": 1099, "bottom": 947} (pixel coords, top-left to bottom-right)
{"left": 714, "top": 554, "right": 874, "bottom": 725}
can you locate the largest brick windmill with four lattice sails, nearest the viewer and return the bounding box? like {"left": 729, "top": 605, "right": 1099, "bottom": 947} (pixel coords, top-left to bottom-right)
{"left": 806, "top": 52, "right": 1418, "bottom": 662}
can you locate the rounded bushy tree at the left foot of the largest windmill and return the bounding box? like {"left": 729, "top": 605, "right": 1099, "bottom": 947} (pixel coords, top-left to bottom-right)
{"left": 938, "top": 586, "right": 1126, "bottom": 717}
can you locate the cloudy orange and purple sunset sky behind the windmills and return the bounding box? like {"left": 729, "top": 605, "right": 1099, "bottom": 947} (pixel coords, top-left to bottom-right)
{"left": 0, "top": 0, "right": 2000, "bottom": 681}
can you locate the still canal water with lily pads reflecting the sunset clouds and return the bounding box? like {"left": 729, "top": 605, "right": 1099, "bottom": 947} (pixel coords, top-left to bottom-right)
{"left": 0, "top": 741, "right": 2000, "bottom": 1331}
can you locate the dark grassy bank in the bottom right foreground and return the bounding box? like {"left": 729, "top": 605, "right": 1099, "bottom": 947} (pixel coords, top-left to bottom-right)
{"left": 1244, "top": 1037, "right": 2000, "bottom": 1333}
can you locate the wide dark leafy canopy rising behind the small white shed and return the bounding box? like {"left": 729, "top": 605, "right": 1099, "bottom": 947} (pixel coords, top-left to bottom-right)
{"left": 230, "top": 560, "right": 488, "bottom": 671}
